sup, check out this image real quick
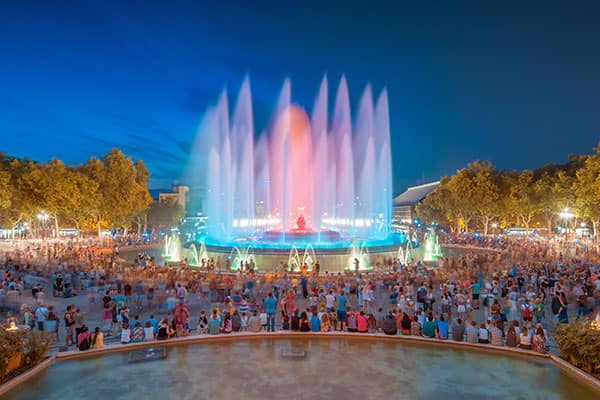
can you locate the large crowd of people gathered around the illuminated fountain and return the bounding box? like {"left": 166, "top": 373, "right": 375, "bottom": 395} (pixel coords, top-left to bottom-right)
{"left": 3, "top": 231, "right": 600, "bottom": 352}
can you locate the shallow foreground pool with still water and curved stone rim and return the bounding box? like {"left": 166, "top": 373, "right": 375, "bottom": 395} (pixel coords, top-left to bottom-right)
{"left": 3, "top": 338, "right": 598, "bottom": 400}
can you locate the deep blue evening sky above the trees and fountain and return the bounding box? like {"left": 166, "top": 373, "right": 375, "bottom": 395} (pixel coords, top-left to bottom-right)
{"left": 0, "top": 0, "right": 600, "bottom": 192}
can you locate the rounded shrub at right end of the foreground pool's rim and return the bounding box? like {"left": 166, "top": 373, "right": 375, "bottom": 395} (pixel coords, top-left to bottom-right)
{"left": 555, "top": 318, "right": 600, "bottom": 378}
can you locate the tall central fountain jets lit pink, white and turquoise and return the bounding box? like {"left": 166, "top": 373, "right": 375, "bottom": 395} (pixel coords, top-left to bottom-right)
{"left": 186, "top": 77, "right": 420, "bottom": 270}
